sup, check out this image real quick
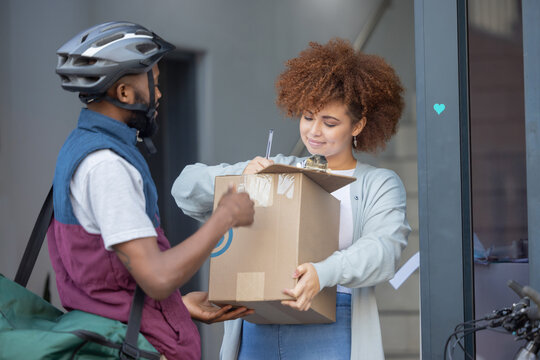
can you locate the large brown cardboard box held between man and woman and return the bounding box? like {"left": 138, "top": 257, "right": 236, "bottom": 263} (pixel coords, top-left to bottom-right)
{"left": 209, "top": 165, "right": 355, "bottom": 324}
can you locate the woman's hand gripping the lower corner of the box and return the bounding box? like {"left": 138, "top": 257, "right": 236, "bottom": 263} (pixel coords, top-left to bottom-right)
{"left": 281, "top": 263, "right": 320, "bottom": 311}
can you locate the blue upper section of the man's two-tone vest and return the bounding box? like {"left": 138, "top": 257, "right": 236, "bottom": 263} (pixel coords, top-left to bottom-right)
{"left": 53, "top": 109, "right": 160, "bottom": 227}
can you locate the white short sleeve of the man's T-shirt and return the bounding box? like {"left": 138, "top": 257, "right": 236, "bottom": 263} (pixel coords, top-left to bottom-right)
{"left": 70, "top": 149, "right": 157, "bottom": 251}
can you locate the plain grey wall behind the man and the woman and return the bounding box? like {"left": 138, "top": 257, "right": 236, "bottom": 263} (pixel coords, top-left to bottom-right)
{"left": 0, "top": 0, "right": 416, "bottom": 359}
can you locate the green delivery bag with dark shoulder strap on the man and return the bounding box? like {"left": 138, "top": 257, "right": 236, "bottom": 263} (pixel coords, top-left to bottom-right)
{"left": 0, "top": 188, "right": 160, "bottom": 360}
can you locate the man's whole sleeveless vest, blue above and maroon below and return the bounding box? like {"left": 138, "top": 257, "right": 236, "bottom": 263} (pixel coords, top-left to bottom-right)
{"left": 47, "top": 109, "right": 201, "bottom": 359}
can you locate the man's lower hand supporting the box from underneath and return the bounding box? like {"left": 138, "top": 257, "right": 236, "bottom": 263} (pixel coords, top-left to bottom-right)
{"left": 182, "top": 291, "right": 254, "bottom": 324}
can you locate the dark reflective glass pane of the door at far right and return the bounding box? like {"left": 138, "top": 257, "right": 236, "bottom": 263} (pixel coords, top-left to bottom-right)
{"left": 468, "top": 0, "right": 529, "bottom": 360}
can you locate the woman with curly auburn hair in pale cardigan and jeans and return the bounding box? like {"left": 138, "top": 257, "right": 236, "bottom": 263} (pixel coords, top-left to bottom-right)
{"left": 172, "top": 39, "right": 410, "bottom": 360}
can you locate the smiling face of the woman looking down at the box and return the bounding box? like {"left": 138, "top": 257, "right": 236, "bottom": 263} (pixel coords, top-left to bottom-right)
{"left": 300, "top": 101, "right": 363, "bottom": 165}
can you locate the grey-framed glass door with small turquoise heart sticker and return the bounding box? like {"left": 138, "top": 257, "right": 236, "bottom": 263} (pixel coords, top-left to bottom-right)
{"left": 415, "top": 0, "right": 540, "bottom": 359}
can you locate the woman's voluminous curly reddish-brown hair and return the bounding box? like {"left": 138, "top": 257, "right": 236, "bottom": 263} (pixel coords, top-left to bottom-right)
{"left": 276, "top": 39, "right": 404, "bottom": 152}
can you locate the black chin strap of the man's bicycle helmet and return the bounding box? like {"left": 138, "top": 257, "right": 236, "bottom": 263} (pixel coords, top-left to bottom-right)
{"left": 103, "top": 69, "right": 157, "bottom": 155}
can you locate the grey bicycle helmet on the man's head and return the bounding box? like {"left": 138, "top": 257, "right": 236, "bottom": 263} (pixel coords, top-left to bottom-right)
{"left": 56, "top": 21, "right": 174, "bottom": 99}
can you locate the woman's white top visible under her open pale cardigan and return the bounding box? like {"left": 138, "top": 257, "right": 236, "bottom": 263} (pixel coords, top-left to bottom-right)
{"left": 332, "top": 169, "right": 354, "bottom": 294}
